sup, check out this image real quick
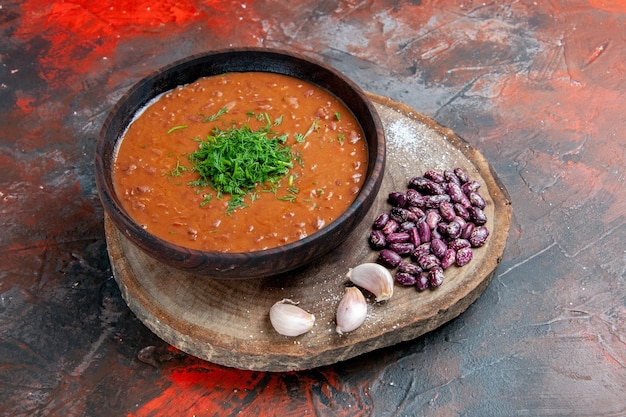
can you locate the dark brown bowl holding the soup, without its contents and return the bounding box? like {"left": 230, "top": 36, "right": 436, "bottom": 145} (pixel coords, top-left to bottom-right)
{"left": 95, "top": 48, "right": 385, "bottom": 279}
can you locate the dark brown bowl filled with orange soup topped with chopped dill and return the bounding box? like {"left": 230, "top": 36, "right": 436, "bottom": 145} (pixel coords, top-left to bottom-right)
{"left": 95, "top": 48, "right": 385, "bottom": 279}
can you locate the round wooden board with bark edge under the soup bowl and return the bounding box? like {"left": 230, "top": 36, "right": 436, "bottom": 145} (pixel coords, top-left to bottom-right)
{"left": 105, "top": 95, "right": 511, "bottom": 371}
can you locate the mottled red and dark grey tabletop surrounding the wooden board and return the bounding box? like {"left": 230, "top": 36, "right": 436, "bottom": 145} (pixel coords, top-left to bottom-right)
{"left": 0, "top": 0, "right": 626, "bottom": 417}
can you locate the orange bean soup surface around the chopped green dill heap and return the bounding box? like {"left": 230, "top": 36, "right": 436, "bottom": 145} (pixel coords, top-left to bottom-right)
{"left": 113, "top": 72, "right": 367, "bottom": 252}
